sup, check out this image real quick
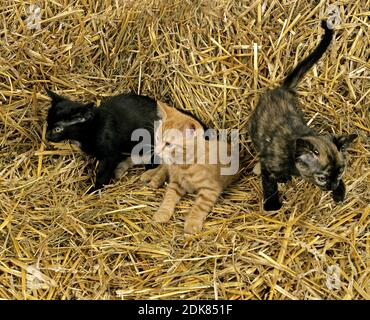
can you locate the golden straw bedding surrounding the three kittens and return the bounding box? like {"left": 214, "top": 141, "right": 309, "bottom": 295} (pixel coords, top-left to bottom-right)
{"left": 0, "top": 0, "right": 370, "bottom": 299}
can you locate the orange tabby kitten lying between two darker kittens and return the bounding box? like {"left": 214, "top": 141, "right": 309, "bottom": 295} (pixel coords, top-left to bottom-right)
{"left": 142, "top": 102, "right": 239, "bottom": 234}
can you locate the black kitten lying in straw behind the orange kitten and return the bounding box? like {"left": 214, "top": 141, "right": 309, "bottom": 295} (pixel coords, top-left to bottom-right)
{"left": 46, "top": 90, "right": 159, "bottom": 191}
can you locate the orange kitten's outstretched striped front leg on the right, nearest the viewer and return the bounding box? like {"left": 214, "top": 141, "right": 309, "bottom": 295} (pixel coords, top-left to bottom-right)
{"left": 184, "top": 188, "right": 222, "bottom": 234}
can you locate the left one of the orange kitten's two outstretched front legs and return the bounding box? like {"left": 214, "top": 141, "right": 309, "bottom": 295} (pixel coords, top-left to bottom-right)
{"left": 153, "top": 182, "right": 185, "bottom": 222}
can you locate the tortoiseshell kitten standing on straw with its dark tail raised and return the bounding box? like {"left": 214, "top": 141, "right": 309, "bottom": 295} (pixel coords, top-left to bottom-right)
{"left": 248, "top": 21, "right": 357, "bottom": 210}
